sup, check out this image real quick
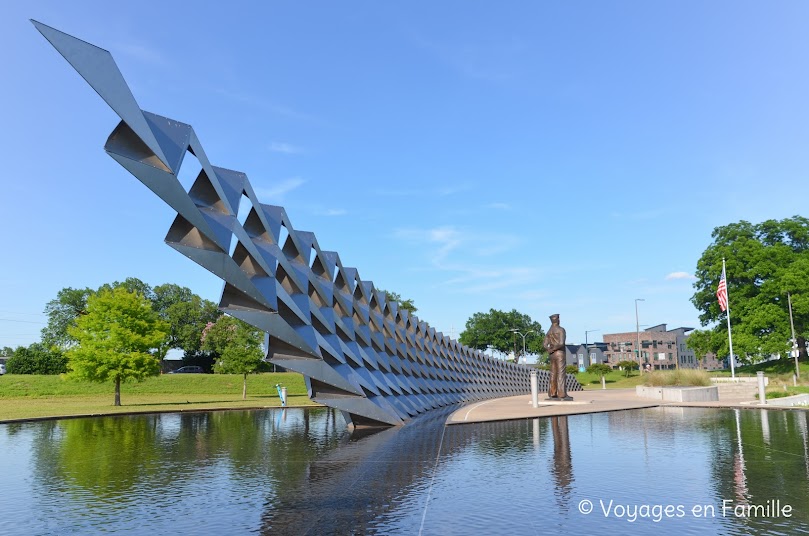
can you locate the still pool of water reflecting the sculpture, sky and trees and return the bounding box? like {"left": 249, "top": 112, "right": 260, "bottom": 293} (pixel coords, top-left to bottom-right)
{"left": 0, "top": 408, "right": 809, "bottom": 535}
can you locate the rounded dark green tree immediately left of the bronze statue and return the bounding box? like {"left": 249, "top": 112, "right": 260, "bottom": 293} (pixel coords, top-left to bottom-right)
{"left": 458, "top": 309, "right": 545, "bottom": 356}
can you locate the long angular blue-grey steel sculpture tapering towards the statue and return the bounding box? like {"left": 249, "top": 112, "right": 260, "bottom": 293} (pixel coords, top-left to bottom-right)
{"left": 32, "top": 21, "right": 581, "bottom": 425}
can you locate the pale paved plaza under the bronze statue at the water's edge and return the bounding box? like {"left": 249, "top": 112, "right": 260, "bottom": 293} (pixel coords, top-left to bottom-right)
{"left": 447, "top": 389, "right": 772, "bottom": 424}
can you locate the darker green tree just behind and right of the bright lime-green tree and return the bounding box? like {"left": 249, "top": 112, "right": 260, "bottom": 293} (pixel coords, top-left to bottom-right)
{"left": 152, "top": 283, "right": 222, "bottom": 360}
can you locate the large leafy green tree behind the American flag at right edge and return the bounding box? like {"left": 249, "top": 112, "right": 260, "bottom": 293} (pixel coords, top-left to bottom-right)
{"left": 691, "top": 216, "right": 809, "bottom": 360}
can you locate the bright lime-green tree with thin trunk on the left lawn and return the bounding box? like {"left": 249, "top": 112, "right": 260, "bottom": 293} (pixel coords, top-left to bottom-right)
{"left": 67, "top": 287, "right": 167, "bottom": 406}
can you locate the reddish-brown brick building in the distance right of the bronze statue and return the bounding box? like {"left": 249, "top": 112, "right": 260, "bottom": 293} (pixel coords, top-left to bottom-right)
{"left": 604, "top": 324, "right": 724, "bottom": 370}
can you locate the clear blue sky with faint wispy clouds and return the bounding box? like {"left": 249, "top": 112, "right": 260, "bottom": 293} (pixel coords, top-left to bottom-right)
{"left": 0, "top": 0, "right": 809, "bottom": 347}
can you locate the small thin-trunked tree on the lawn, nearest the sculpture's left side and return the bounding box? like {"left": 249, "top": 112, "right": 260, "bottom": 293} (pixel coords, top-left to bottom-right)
{"left": 201, "top": 315, "right": 264, "bottom": 400}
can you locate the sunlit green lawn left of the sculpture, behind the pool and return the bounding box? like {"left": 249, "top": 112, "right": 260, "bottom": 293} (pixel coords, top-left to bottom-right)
{"left": 0, "top": 372, "right": 314, "bottom": 421}
